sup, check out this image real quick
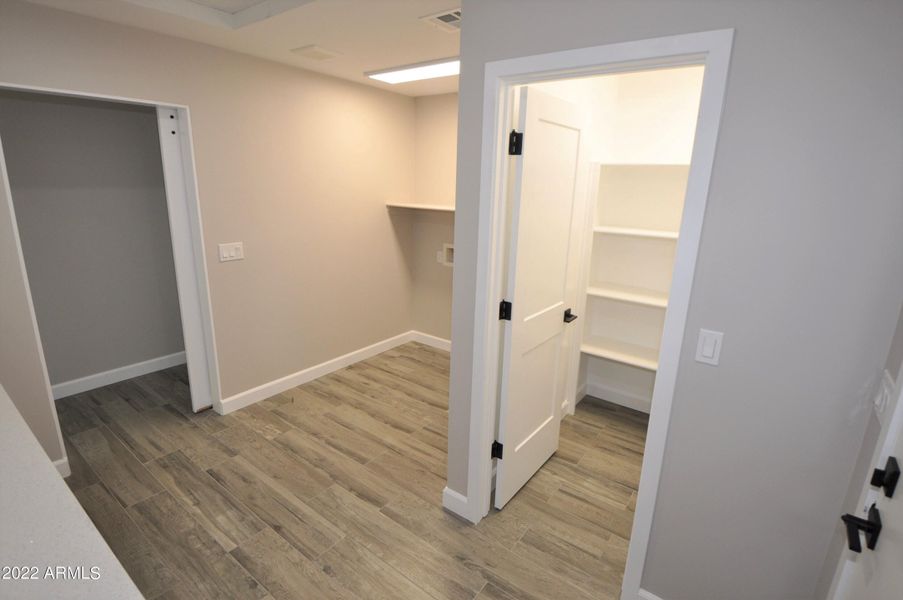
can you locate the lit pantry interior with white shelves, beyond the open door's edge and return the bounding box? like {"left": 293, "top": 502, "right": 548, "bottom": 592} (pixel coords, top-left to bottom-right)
{"left": 536, "top": 66, "right": 703, "bottom": 413}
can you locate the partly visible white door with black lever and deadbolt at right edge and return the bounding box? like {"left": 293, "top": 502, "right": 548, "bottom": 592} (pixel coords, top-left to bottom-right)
{"left": 832, "top": 375, "right": 903, "bottom": 600}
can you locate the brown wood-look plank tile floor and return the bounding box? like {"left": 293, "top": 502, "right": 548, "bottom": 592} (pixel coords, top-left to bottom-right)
{"left": 58, "top": 343, "right": 646, "bottom": 600}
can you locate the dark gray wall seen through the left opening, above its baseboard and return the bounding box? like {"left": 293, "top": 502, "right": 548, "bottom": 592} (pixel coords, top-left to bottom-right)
{"left": 0, "top": 91, "right": 184, "bottom": 384}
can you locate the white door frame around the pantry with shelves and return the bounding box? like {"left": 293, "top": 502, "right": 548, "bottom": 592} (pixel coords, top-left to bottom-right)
{"left": 456, "top": 29, "right": 734, "bottom": 600}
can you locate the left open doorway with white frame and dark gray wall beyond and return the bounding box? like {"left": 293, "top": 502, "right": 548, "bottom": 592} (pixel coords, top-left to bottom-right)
{"left": 0, "top": 86, "right": 219, "bottom": 475}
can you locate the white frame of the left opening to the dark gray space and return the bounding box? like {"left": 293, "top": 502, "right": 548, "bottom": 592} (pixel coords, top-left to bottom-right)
{"left": 0, "top": 81, "right": 223, "bottom": 414}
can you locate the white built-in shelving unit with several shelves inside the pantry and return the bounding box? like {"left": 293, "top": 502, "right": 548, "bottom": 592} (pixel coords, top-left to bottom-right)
{"left": 580, "top": 165, "right": 689, "bottom": 410}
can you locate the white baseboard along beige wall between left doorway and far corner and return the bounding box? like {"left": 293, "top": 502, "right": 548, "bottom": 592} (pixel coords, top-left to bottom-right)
{"left": 222, "top": 330, "right": 451, "bottom": 415}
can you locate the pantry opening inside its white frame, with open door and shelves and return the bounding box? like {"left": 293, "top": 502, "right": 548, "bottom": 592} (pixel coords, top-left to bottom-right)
{"left": 493, "top": 65, "right": 704, "bottom": 508}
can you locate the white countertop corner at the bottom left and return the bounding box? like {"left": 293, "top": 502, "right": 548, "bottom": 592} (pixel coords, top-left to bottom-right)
{"left": 0, "top": 386, "right": 142, "bottom": 600}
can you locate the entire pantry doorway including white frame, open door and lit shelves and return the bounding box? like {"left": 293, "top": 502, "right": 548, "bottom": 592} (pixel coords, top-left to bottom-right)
{"left": 460, "top": 31, "right": 732, "bottom": 598}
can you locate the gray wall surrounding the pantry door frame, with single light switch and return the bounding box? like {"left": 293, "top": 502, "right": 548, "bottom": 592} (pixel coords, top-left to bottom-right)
{"left": 449, "top": 0, "right": 903, "bottom": 600}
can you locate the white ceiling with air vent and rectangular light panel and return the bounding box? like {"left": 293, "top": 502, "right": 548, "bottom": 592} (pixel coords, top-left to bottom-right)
{"left": 24, "top": 0, "right": 460, "bottom": 96}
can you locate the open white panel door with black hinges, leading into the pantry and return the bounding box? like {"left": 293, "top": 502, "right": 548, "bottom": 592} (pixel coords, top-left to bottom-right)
{"left": 495, "top": 87, "right": 584, "bottom": 508}
